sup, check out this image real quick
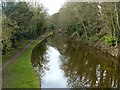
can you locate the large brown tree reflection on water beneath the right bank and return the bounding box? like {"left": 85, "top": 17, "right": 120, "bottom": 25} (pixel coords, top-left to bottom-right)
{"left": 61, "top": 43, "right": 118, "bottom": 88}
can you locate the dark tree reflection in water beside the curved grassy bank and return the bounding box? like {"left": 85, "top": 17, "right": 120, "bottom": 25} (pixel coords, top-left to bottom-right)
{"left": 31, "top": 42, "right": 48, "bottom": 76}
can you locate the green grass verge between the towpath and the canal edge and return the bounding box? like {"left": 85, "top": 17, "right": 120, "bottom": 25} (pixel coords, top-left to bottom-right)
{"left": 2, "top": 33, "right": 52, "bottom": 88}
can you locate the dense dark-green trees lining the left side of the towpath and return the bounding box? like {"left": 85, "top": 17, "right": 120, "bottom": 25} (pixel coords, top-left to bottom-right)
{"left": 2, "top": 2, "right": 46, "bottom": 53}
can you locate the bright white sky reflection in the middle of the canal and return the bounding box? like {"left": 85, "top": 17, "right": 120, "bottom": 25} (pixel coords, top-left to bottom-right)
{"left": 41, "top": 46, "right": 67, "bottom": 88}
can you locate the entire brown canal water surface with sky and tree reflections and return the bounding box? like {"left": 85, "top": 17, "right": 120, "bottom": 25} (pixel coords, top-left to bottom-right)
{"left": 31, "top": 34, "right": 118, "bottom": 88}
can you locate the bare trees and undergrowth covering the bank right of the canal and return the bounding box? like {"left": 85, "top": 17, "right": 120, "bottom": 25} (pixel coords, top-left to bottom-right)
{"left": 50, "top": 2, "right": 120, "bottom": 58}
